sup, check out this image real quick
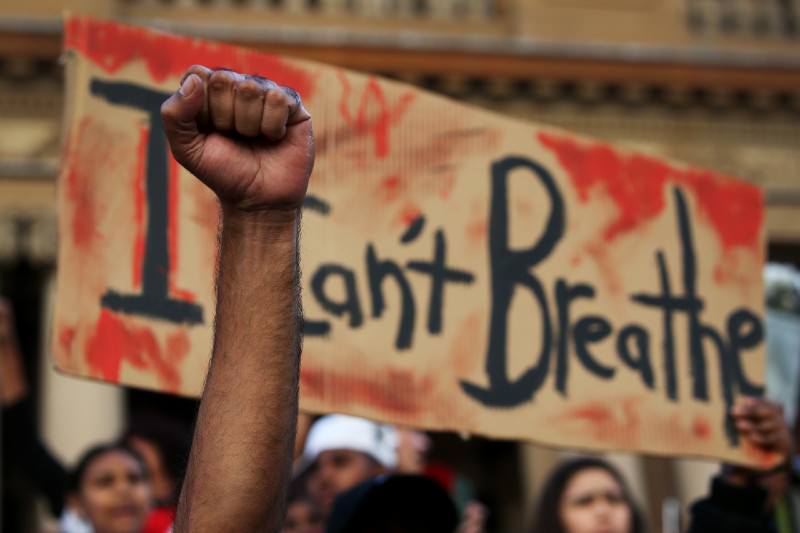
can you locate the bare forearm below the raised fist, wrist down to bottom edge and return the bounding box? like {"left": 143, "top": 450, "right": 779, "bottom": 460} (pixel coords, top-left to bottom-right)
{"left": 175, "top": 209, "right": 300, "bottom": 532}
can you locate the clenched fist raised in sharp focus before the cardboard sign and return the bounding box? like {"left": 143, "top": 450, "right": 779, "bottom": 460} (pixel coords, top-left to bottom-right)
{"left": 161, "top": 65, "right": 314, "bottom": 211}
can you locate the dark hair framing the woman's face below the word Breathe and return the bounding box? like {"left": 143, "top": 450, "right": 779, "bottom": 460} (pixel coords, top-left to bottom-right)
{"left": 530, "top": 457, "right": 646, "bottom": 533}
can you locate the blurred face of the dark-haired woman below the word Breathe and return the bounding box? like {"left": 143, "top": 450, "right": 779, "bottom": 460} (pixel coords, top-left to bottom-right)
{"left": 559, "top": 468, "right": 632, "bottom": 533}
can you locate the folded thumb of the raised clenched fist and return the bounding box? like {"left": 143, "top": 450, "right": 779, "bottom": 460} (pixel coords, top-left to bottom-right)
{"left": 161, "top": 74, "right": 206, "bottom": 170}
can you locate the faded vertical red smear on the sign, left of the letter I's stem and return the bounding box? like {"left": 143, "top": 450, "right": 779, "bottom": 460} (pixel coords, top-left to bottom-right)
{"left": 66, "top": 117, "right": 98, "bottom": 247}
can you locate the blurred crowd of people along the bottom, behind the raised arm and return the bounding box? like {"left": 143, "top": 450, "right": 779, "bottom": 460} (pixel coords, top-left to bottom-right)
{"left": 0, "top": 290, "right": 800, "bottom": 533}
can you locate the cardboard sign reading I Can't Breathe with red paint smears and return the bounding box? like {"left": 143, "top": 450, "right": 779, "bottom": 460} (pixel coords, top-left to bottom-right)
{"left": 53, "top": 18, "right": 771, "bottom": 464}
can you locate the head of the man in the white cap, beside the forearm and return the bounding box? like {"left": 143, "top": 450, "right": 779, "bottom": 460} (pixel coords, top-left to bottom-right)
{"left": 303, "top": 415, "right": 398, "bottom": 516}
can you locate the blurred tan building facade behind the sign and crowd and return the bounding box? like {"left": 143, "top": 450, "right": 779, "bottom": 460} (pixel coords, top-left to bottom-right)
{"left": 0, "top": 0, "right": 800, "bottom": 533}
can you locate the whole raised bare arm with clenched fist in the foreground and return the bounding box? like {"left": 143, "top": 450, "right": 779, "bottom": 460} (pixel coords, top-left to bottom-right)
{"left": 162, "top": 67, "right": 313, "bottom": 532}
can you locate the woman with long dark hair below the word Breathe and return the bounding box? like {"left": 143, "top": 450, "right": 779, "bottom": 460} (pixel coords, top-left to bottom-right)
{"left": 530, "top": 457, "right": 645, "bottom": 533}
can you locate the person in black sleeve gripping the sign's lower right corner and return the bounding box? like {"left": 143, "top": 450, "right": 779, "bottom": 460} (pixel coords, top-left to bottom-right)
{"left": 689, "top": 398, "right": 793, "bottom": 533}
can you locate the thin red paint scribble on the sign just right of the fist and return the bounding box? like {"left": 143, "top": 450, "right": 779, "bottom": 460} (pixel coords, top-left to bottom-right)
{"left": 337, "top": 71, "right": 415, "bottom": 159}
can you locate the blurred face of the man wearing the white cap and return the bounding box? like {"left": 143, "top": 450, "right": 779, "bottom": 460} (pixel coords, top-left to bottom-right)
{"left": 308, "top": 450, "right": 385, "bottom": 516}
